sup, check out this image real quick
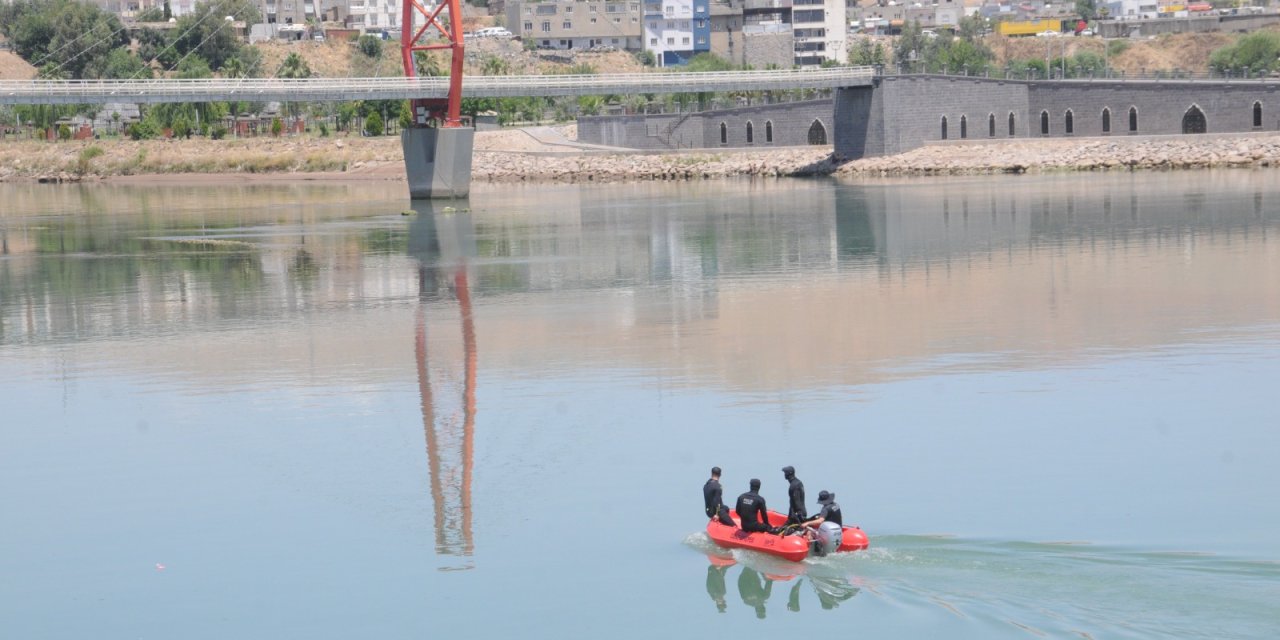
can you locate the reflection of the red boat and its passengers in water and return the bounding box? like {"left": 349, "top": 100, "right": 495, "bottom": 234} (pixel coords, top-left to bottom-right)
{"left": 707, "top": 554, "right": 858, "bottom": 620}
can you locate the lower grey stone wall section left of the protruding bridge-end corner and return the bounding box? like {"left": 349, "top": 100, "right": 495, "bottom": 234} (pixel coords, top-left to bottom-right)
{"left": 577, "top": 100, "right": 835, "bottom": 150}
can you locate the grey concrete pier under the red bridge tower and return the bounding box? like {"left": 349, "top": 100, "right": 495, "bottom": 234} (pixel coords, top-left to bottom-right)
{"left": 401, "top": 127, "right": 476, "bottom": 200}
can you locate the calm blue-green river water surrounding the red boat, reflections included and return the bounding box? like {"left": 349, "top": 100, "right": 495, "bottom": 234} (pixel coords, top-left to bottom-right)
{"left": 0, "top": 172, "right": 1280, "bottom": 639}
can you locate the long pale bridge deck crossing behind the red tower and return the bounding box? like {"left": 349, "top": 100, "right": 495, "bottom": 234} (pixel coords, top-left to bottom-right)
{"left": 0, "top": 67, "right": 874, "bottom": 105}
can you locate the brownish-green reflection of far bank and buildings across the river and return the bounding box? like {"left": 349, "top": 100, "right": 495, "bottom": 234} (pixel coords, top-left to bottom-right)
{"left": 0, "top": 173, "right": 1280, "bottom": 389}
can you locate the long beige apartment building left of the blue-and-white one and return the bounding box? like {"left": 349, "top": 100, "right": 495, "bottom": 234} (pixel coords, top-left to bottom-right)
{"left": 507, "top": 0, "right": 645, "bottom": 51}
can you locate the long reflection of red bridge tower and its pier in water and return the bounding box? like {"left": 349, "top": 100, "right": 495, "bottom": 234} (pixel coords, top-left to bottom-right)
{"left": 408, "top": 202, "right": 477, "bottom": 570}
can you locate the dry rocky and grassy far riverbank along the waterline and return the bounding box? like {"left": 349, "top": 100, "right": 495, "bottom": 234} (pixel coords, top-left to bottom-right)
{"left": 0, "top": 128, "right": 1280, "bottom": 183}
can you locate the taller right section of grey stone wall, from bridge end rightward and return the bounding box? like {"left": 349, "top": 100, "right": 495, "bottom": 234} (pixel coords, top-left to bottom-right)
{"left": 835, "top": 76, "right": 1280, "bottom": 159}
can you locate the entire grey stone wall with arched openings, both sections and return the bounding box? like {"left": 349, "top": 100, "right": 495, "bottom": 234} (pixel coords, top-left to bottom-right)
{"left": 579, "top": 76, "right": 1280, "bottom": 159}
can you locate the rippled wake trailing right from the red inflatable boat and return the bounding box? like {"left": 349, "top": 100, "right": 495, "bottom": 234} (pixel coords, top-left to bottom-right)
{"left": 685, "top": 532, "right": 1280, "bottom": 637}
